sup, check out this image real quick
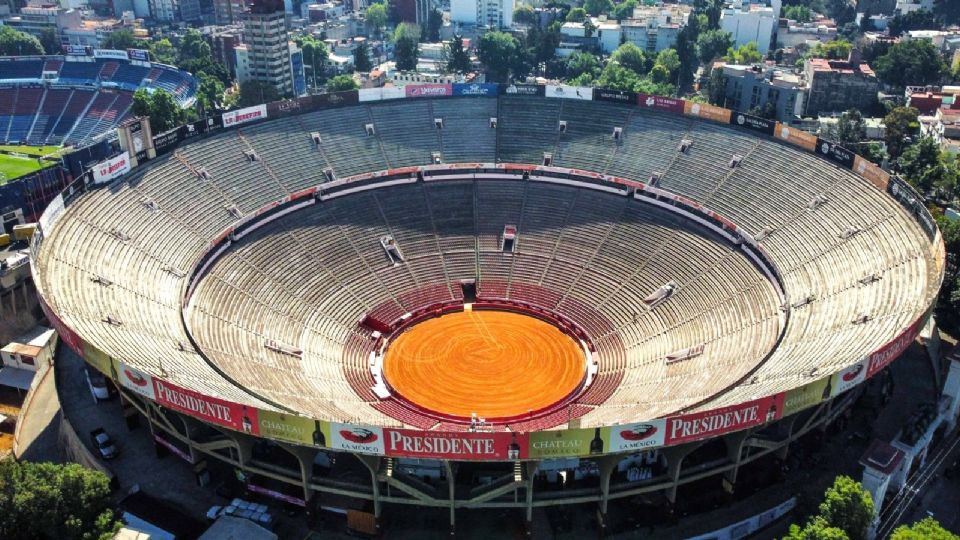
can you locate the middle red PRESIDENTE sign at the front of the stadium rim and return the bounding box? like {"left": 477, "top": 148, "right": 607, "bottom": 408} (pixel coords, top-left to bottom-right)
{"left": 383, "top": 429, "right": 527, "bottom": 460}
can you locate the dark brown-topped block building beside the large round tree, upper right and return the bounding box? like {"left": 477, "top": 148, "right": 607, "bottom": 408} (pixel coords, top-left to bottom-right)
{"left": 803, "top": 50, "right": 880, "bottom": 116}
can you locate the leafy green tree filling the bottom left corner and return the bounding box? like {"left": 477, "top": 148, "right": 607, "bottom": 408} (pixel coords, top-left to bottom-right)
{"left": 0, "top": 459, "right": 121, "bottom": 540}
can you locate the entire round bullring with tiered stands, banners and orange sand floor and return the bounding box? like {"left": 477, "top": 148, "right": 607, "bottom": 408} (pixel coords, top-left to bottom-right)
{"left": 33, "top": 85, "right": 943, "bottom": 536}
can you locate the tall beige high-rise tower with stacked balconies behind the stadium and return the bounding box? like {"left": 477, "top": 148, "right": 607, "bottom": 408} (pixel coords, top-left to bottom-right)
{"left": 234, "top": 0, "right": 306, "bottom": 96}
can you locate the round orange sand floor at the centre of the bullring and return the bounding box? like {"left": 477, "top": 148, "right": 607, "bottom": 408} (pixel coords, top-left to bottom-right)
{"left": 383, "top": 310, "right": 585, "bottom": 419}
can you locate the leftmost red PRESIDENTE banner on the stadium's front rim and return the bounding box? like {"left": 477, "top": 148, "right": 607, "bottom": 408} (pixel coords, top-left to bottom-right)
{"left": 153, "top": 379, "right": 260, "bottom": 435}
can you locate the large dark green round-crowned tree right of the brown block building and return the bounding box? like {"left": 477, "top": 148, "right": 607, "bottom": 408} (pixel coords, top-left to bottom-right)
{"left": 873, "top": 39, "right": 946, "bottom": 88}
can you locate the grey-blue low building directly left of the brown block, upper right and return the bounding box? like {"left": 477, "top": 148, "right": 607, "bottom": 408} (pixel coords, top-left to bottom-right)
{"left": 714, "top": 63, "right": 807, "bottom": 122}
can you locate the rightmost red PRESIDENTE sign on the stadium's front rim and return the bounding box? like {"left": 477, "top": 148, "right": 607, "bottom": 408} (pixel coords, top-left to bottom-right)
{"left": 665, "top": 393, "right": 783, "bottom": 445}
